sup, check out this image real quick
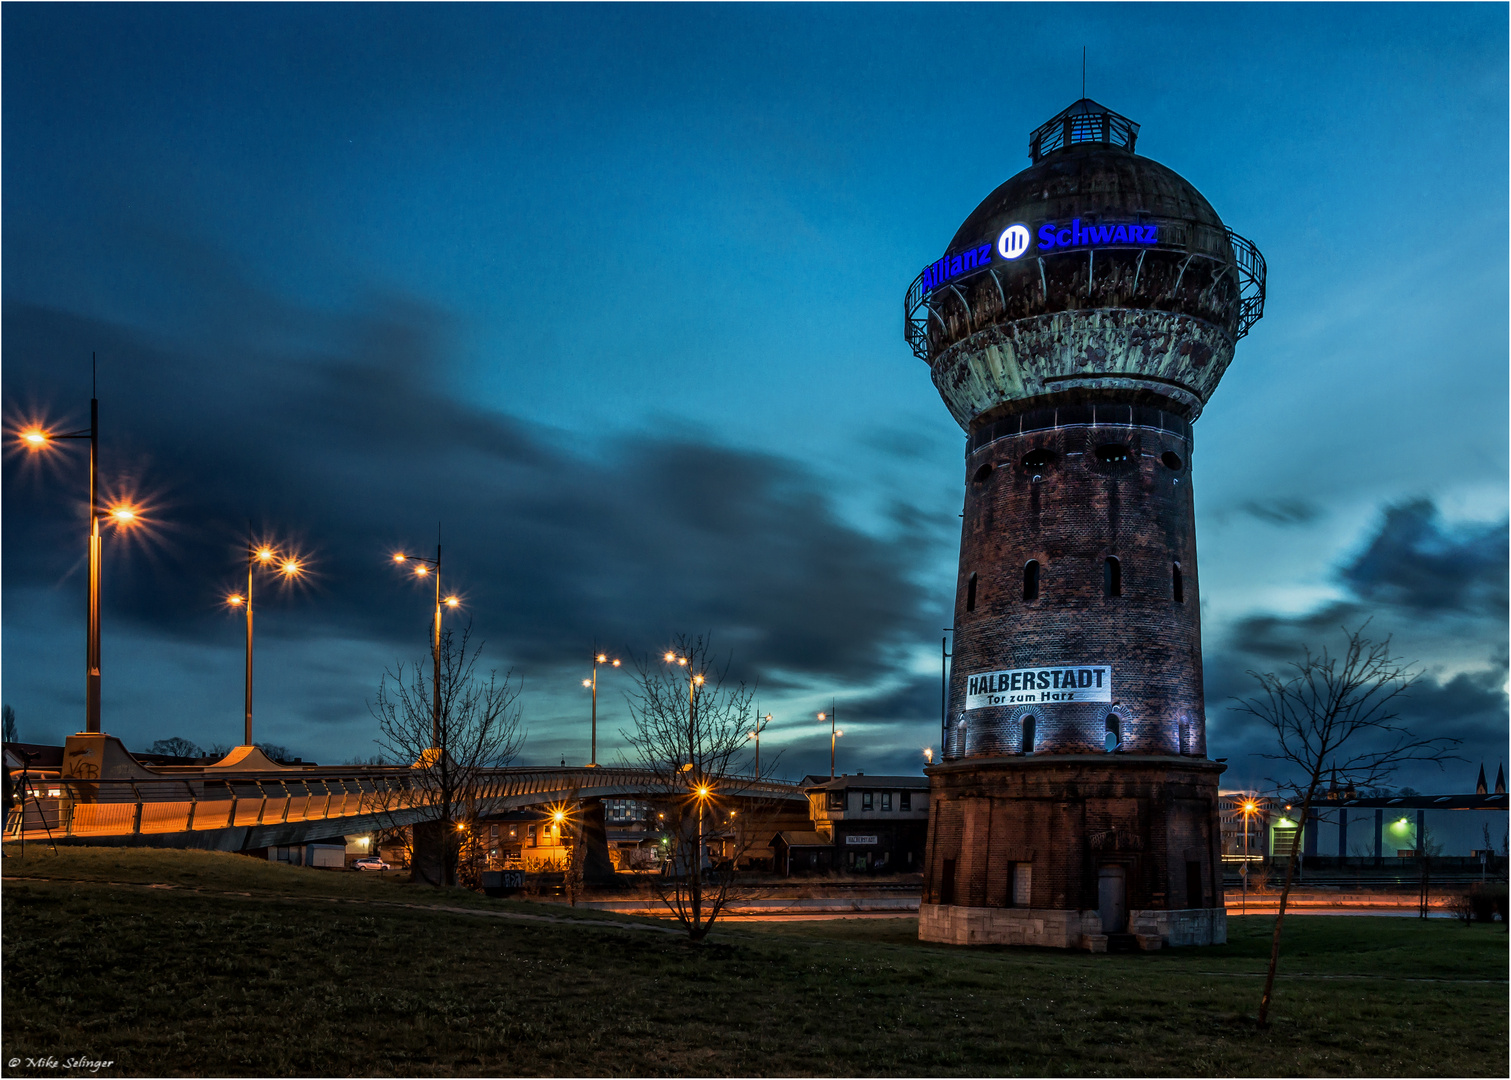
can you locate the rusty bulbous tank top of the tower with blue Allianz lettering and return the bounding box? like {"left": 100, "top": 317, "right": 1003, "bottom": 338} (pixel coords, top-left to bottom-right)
{"left": 905, "top": 98, "right": 1265, "bottom": 430}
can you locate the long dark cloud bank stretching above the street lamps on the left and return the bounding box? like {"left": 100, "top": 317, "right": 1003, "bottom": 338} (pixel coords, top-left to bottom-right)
{"left": 3, "top": 291, "right": 938, "bottom": 683}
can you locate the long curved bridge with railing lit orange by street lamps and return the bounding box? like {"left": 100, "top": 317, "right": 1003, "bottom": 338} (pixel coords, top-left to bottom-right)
{"left": 5, "top": 736, "right": 807, "bottom": 850}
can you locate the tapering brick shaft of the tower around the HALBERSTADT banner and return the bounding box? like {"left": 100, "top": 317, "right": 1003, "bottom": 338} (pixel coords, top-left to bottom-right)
{"left": 944, "top": 413, "right": 1206, "bottom": 760}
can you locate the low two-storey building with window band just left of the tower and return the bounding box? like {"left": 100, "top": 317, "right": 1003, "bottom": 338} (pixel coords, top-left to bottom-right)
{"left": 802, "top": 772, "right": 929, "bottom": 873}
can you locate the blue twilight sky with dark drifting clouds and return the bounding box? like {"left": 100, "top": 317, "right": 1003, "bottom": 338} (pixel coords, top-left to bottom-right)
{"left": 0, "top": 5, "right": 1508, "bottom": 790}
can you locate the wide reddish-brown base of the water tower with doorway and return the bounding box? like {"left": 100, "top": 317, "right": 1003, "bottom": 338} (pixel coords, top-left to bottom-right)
{"left": 919, "top": 754, "right": 1227, "bottom": 952}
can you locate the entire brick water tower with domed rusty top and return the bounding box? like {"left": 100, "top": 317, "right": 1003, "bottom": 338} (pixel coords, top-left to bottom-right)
{"left": 907, "top": 100, "right": 1265, "bottom": 950}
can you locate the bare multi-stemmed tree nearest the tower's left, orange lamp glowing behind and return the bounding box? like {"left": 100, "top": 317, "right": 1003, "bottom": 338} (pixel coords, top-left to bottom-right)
{"left": 620, "top": 634, "right": 775, "bottom": 941}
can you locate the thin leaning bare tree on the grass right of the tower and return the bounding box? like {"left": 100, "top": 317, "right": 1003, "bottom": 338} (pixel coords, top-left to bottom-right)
{"left": 1236, "top": 622, "right": 1458, "bottom": 1024}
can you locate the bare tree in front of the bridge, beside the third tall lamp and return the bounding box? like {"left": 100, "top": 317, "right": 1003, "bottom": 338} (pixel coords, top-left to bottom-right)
{"left": 369, "top": 625, "right": 524, "bottom": 885}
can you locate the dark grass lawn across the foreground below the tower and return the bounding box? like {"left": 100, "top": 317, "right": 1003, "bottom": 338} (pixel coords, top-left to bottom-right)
{"left": 0, "top": 846, "right": 1511, "bottom": 1077}
